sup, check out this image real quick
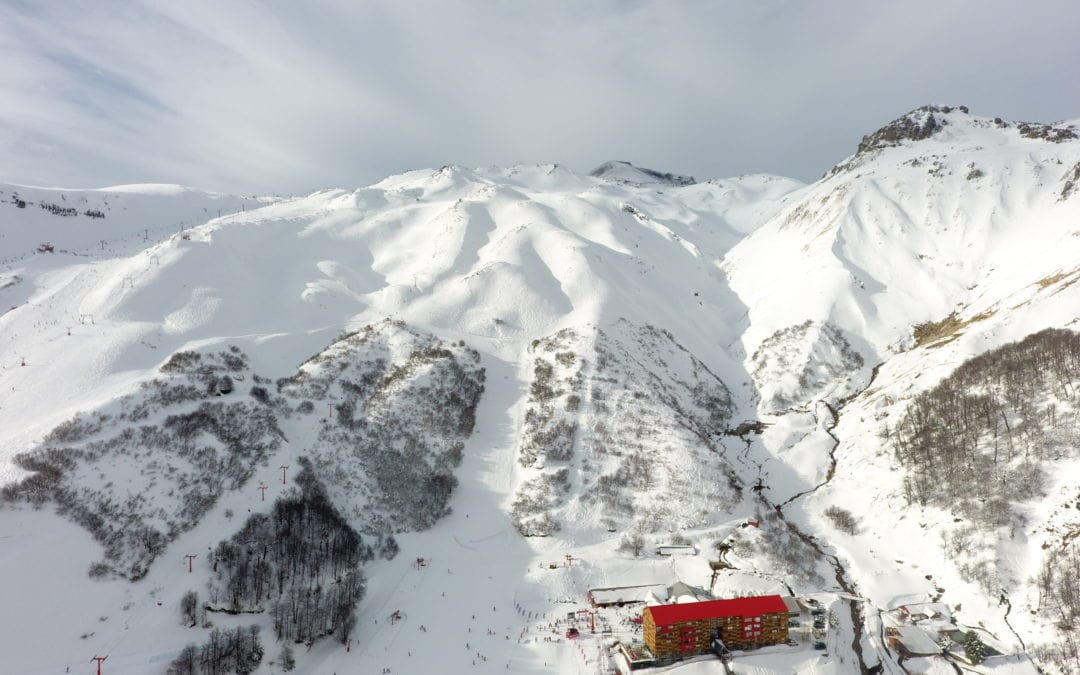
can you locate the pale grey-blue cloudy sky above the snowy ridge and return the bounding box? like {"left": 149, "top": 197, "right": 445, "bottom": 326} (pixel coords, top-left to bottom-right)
{"left": 0, "top": 0, "right": 1080, "bottom": 193}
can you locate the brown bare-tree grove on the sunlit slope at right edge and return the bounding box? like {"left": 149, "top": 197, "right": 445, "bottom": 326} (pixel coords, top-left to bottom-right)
{"left": 891, "top": 328, "right": 1080, "bottom": 525}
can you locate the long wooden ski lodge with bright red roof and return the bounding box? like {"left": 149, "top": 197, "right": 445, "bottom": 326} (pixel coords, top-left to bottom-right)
{"left": 642, "top": 595, "right": 788, "bottom": 661}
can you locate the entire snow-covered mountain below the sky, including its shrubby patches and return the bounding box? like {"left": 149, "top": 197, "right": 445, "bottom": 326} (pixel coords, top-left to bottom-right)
{"left": 0, "top": 106, "right": 1080, "bottom": 673}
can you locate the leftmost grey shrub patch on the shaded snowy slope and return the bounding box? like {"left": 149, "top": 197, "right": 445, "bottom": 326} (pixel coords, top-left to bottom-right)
{"left": 2, "top": 348, "right": 283, "bottom": 579}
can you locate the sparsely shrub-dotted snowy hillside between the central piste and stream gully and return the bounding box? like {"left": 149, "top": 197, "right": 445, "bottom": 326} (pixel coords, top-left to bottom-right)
{"left": 511, "top": 321, "right": 739, "bottom": 536}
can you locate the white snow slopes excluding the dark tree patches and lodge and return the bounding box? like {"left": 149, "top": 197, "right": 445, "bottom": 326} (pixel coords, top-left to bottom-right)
{"left": 0, "top": 107, "right": 1080, "bottom": 673}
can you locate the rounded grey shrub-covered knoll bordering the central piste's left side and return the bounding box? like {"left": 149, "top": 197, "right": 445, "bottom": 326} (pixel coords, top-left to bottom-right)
{"left": 278, "top": 321, "right": 485, "bottom": 537}
